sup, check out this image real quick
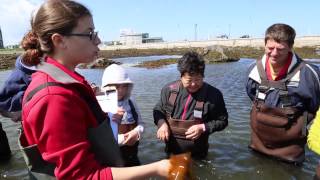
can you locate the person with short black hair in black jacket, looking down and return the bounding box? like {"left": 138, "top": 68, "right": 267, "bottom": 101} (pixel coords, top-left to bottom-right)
{"left": 153, "top": 52, "right": 228, "bottom": 159}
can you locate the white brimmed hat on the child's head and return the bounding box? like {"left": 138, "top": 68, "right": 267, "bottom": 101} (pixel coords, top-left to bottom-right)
{"left": 101, "top": 64, "right": 133, "bottom": 88}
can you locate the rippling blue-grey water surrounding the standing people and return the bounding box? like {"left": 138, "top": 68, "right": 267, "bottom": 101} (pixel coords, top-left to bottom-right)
{"left": 0, "top": 58, "right": 318, "bottom": 180}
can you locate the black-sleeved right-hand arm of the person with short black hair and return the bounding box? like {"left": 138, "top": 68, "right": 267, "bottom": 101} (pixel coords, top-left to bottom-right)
{"left": 204, "top": 91, "right": 228, "bottom": 134}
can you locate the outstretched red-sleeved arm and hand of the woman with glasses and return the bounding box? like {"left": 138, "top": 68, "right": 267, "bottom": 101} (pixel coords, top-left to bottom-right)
{"left": 23, "top": 94, "right": 170, "bottom": 180}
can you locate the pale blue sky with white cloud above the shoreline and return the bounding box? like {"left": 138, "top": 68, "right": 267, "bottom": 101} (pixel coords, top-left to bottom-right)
{"left": 0, "top": 0, "right": 320, "bottom": 45}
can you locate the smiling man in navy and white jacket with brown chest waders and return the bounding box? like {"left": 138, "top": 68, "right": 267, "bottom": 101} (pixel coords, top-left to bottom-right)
{"left": 246, "top": 24, "right": 320, "bottom": 164}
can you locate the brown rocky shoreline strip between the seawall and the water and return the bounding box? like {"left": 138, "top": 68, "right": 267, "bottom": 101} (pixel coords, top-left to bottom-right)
{"left": 0, "top": 46, "right": 320, "bottom": 70}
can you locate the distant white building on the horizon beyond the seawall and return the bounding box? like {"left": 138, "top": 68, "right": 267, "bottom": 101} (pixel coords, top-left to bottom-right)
{"left": 120, "top": 29, "right": 163, "bottom": 45}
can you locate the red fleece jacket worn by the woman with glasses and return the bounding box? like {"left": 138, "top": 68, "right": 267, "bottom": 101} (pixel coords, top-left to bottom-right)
{"left": 22, "top": 58, "right": 112, "bottom": 180}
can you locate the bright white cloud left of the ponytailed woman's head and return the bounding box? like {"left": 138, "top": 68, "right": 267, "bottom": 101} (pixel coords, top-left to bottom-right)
{"left": 0, "top": 0, "right": 43, "bottom": 46}
